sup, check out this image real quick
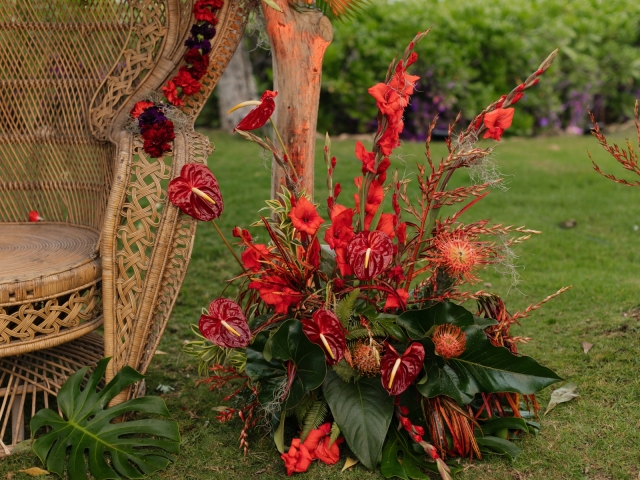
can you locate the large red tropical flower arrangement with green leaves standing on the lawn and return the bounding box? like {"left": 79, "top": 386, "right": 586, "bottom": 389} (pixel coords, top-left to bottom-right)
{"left": 176, "top": 32, "right": 565, "bottom": 479}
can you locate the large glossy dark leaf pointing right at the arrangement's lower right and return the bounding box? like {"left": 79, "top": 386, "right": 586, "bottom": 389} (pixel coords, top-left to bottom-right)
{"left": 418, "top": 325, "right": 562, "bottom": 405}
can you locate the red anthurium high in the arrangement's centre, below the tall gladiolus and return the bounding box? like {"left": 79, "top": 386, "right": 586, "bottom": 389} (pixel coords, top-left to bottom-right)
{"left": 347, "top": 230, "right": 393, "bottom": 280}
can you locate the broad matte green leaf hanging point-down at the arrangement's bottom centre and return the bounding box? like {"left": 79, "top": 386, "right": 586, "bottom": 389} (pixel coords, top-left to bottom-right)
{"left": 322, "top": 370, "right": 393, "bottom": 470}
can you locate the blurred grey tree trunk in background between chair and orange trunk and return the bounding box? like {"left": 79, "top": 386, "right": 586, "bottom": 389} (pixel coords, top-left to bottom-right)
{"left": 216, "top": 35, "right": 258, "bottom": 133}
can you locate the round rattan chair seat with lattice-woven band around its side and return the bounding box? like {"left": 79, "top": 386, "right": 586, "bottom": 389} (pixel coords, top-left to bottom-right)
{"left": 0, "top": 223, "right": 102, "bottom": 357}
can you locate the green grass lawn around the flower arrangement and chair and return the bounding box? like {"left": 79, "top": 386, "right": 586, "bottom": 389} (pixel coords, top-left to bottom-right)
{"left": 0, "top": 132, "right": 640, "bottom": 480}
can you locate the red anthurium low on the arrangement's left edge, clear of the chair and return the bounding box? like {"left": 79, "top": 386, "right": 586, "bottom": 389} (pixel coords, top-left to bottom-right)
{"left": 198, "top": 298, "right": 251, "bottom": 348}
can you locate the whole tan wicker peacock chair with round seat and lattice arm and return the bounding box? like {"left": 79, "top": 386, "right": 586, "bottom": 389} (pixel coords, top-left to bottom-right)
{"left": 0, "top": 0, "right": 248, "bottom": 456}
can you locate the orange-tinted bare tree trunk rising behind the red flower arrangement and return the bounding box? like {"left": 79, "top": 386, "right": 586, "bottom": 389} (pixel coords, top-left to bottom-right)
{"left": 262, "top": 0, "right": 333, "bottom": 198}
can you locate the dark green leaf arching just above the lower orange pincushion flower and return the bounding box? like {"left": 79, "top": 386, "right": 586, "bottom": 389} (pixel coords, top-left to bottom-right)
{"left": 396, "top": 302, "right": 474, "bottom": 340}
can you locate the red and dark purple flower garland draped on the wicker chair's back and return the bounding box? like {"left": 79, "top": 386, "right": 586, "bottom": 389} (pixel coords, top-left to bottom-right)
{"left": 131, "top": 0, "right": 223, "bottom": 158}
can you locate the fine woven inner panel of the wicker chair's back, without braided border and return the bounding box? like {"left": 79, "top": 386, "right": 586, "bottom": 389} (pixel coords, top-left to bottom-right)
{"left": 0, "top": 0, "right": 140, "bottom": 229}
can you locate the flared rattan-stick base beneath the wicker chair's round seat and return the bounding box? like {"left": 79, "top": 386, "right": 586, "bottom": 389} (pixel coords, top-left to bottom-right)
{"left": 0, "top": 333, "right": 104, "bottom": 458}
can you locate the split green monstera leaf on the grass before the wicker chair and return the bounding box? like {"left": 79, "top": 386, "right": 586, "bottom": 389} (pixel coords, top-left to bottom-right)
{"left": 30, "top": 358, "right": 180, "bottom": 480}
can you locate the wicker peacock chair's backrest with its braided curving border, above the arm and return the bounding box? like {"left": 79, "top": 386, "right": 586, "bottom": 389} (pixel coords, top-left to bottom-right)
{"left": 0, "top": 0, "right": 244, "bottom": 229}
